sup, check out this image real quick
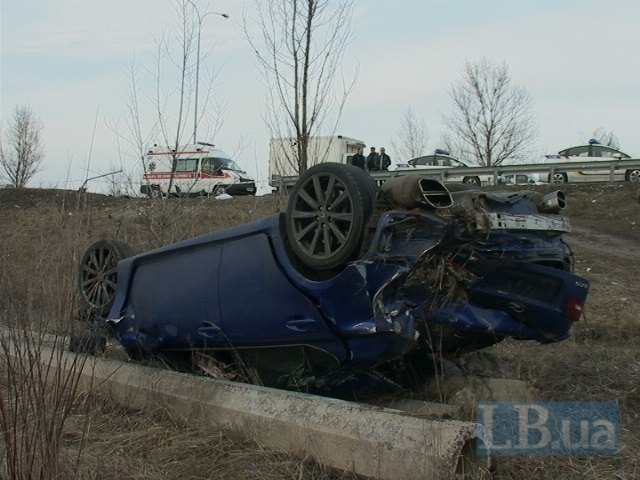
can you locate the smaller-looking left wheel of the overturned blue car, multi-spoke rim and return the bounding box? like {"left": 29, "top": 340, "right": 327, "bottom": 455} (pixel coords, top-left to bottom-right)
{"left": 78, "top": 240, "right": 133, "bottom": 317}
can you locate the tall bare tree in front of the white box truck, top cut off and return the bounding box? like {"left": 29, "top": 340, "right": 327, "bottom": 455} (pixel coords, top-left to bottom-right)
{"left": 244, "top": 0, "right": 353, "bottom": 173}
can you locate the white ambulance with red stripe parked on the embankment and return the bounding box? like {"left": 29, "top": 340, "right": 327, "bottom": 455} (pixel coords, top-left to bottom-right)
{"left": 140, "top": 142, "right": 256, "bottom": 197}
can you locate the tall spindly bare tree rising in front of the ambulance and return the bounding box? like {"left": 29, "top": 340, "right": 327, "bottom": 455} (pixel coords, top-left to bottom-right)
{"left": 112, "top": 0, "right": 229, "bottom": 185}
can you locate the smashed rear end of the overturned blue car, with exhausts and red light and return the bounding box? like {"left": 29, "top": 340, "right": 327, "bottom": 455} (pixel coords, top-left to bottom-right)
{"left": 368, "top": 176, "right": 589, "bottom": 356}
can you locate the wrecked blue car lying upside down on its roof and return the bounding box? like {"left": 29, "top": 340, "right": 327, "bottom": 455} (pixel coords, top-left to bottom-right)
{"left": 72, "top": 163, "right": 589, "bottom": 392}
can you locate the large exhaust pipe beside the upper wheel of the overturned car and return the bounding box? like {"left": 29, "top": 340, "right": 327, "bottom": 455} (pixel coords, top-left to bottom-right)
{"left": 380, "top": 174, "right": 453, "bottom": 208}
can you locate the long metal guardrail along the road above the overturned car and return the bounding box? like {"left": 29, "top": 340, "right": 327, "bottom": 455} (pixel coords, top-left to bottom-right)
{"left": 271, "top": 159, "right": 640, "bottom": 188}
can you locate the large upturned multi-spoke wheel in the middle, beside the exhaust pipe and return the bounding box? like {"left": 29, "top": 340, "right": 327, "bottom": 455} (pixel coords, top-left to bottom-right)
{"left": 285, "top": 163, "right": 373, "bottom": 270}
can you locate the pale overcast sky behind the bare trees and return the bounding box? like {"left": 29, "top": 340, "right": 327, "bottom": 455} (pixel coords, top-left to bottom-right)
{"left": 0, "top": 0, "right": 640, "bottom": 191}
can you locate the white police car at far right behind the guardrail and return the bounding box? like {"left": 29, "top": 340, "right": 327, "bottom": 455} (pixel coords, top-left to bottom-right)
{"left": 544, "top": 139, "right": 640, "bottom": 183}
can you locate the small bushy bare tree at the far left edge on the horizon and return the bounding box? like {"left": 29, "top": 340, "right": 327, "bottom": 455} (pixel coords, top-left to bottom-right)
{"left": 0, "top": 106, "right": 44, "bottom": 188}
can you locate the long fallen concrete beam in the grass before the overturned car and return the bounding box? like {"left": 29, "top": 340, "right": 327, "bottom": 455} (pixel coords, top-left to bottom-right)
{"left": 28, "top": 350, "right": 488, "bottom": 479}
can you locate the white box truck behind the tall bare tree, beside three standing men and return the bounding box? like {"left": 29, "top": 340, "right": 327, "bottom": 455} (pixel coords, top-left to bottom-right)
{"left": 269, "top": 135, "right": 365, "bottom": 189}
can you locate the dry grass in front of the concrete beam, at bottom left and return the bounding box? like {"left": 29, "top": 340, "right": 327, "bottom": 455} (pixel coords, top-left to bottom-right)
{"left": 64, "top": 398, "right": 356, "bottom": 480}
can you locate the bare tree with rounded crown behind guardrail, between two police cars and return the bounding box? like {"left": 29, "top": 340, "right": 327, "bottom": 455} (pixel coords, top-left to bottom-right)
{"left": 444, "top": 59, "right": 536, "bottom": 166}
